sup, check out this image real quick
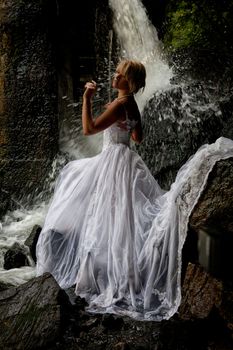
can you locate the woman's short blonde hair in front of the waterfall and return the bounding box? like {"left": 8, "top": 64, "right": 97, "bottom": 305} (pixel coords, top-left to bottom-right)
{"left": 117, "top": 59, "right": 146, "bottom": 93}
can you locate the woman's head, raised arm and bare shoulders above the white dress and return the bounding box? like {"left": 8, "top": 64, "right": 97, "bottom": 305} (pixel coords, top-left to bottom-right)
{"left": 82, "top": 60, "right": 146, "bottom": 143}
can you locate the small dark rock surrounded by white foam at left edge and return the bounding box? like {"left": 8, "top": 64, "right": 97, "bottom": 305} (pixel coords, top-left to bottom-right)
{"left": 3, "top": 242, "right": 30, "bottom": 270}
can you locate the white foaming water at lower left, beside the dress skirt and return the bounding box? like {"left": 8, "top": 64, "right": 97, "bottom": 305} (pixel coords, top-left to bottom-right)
{"left": 0, "top": 156, "right": 67, "bottom": 285}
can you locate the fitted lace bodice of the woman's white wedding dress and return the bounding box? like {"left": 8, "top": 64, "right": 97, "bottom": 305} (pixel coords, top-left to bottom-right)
{"left": 102, "top": 119, "right": 137, "bottom": 150}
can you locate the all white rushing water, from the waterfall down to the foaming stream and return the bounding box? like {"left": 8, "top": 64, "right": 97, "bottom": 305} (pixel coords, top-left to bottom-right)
{"left": 0, "top": 0, "right": 226, "bottom": 285}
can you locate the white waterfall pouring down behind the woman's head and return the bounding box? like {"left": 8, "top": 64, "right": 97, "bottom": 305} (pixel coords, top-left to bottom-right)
{"left": 109, "top": 0, "right": 173, "bottom": 110}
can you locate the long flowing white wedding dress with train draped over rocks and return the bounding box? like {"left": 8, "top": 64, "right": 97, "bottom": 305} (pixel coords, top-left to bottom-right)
{"left": 37, "top": 115, "right": 233, "bottom": 321}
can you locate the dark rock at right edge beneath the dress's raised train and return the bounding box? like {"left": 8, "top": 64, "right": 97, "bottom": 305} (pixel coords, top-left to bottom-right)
{"left": 190, "top": 158, "right": 233, "bottom": 282}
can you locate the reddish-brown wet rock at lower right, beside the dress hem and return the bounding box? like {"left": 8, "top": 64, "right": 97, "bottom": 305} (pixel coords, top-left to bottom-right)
{"left": 178, "top": 263, "right": 233, "bottom": 340}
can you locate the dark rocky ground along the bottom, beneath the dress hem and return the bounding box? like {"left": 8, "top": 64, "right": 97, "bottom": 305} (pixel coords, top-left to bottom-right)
{"left": 0, "top": 270, "right": 232, "bottom": 350}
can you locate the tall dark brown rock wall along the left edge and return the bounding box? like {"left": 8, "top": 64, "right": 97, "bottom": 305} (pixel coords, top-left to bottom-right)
{"left": 0, "top": 0, "right": 58, "bottom": 217}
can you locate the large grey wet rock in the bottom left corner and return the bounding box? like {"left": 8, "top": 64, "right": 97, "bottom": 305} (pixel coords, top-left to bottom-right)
{"left": 0, "top": 274, "right": 68, "bottom": 350}
